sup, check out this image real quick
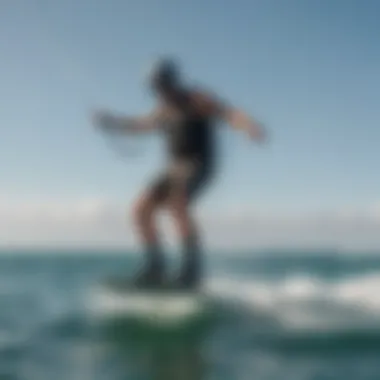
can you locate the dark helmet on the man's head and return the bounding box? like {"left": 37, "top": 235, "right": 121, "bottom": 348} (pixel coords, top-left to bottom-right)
{"left": 149, "top": 58, "right": 179, "bottom": 89}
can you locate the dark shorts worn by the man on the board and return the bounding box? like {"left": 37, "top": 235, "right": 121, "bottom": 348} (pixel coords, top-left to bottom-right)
{"left": 151, "top": 161, "right": 212, "bottom": 202}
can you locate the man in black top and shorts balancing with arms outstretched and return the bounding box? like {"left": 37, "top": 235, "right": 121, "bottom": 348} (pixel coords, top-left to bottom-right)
{"left": 95, "top": 59, "right": 264, "bottom": 288}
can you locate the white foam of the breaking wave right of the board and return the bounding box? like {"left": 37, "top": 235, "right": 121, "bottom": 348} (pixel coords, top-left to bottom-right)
{"left": 208, "top": 273, "right": 380, "bottom": 330}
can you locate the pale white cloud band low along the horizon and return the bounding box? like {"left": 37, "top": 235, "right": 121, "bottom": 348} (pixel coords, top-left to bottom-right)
{"left": 0, "top": 197, "right": 380, "bottom": 250}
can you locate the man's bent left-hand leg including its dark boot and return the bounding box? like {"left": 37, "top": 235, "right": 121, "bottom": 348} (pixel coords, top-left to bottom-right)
{"left": 134, "top": 177, "right": 171, "bottom": 285}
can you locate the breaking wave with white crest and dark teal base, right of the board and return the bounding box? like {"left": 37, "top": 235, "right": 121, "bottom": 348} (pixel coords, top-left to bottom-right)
{"left": 207, "top": 273, "right": 380, "bottom": 349}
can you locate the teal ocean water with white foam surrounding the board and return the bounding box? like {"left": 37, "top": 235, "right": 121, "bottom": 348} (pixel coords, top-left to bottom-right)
{"left": 0, "top": 251, "right": 380, "bottom": 380}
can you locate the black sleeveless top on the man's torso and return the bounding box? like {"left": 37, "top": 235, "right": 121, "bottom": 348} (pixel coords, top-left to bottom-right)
{"left": 167, "top": 93, "right": 215, "bottom": 165}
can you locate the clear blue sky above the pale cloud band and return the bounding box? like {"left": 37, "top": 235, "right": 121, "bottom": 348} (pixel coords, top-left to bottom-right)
{"left": 0, "top": 0, "right": 380, "bottom": 212}
